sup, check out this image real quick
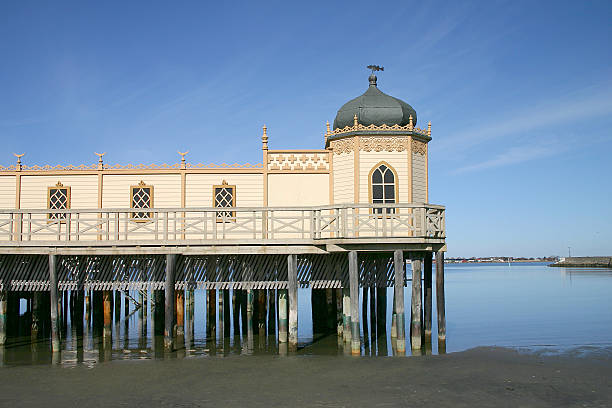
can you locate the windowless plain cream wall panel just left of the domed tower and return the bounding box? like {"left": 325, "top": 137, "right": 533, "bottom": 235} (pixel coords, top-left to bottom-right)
{"left": 268, "top": 174, "right": 329, "bottom": 207}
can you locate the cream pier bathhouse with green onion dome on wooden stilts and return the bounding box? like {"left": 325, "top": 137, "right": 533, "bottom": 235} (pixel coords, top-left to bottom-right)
{"left": 0, "top": 73, "right": 446, "bottom": 354}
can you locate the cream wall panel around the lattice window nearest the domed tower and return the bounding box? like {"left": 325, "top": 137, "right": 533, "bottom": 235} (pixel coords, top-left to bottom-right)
{"left": 186, "top": 174, "right": 263, "bottom": 207}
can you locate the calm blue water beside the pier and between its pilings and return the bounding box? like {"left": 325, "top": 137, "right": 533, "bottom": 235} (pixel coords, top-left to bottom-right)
{"left": 0, "top": 263, "right": 612, "bottom": 366}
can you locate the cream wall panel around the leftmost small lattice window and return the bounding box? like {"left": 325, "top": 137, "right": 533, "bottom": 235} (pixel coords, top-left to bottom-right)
{"left": 20, "top": 174, "right": 98, "bottom": 209}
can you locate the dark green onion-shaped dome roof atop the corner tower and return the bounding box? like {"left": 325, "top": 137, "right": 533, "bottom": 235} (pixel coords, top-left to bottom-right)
{"left": 334, "top": 75, "right": 417, "bottom": 129}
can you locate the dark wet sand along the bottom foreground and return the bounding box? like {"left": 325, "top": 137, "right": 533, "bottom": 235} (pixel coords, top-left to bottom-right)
{"left": 0, "top": 348, "right": 612, "bottom": 407}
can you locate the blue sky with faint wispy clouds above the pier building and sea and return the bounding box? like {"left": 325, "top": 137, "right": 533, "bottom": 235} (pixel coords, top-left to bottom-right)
{"left": 0, "top": 1, "right": 612, "bottom": 256}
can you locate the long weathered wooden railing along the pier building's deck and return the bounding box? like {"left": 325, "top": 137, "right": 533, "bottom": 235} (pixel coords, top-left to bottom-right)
{"left": 0, "top": 204, "right": 445, "bottom": 246}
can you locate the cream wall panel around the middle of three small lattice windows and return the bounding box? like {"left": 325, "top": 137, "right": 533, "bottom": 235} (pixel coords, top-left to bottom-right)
{"left": 100, "top": 174, "right": 181, "bottom": 208}
